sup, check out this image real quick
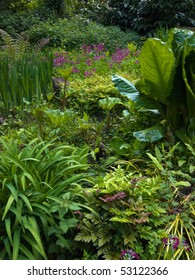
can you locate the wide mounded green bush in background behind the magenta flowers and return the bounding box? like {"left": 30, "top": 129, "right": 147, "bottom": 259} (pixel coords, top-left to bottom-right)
{"left": 26, "top": 17, "right": 139, "bottom": 51}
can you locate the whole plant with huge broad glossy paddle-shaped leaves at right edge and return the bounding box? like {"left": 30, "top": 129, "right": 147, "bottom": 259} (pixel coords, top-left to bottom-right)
{"left": 113, "top": 29, "right": 195, "bottom": 142}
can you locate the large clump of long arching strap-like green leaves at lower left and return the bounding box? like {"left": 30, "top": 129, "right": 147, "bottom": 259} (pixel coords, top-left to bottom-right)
{"left": 0, "top": 139, "right": 88, "bottom": 260}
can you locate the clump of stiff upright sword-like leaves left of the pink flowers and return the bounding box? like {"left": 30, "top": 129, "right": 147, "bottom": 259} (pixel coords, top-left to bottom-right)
{"left": 0, "top": 53, "right": 53, "bottom": 114}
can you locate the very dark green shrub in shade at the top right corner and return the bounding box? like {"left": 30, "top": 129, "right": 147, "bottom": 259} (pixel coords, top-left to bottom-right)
{"left": 88, "top": 0, "right": 195, "bottom": 33}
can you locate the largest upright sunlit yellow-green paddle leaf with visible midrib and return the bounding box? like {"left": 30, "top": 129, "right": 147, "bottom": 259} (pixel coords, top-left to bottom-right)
{"left": 139, "top": 38, "right": 175, "bottom": 105}
